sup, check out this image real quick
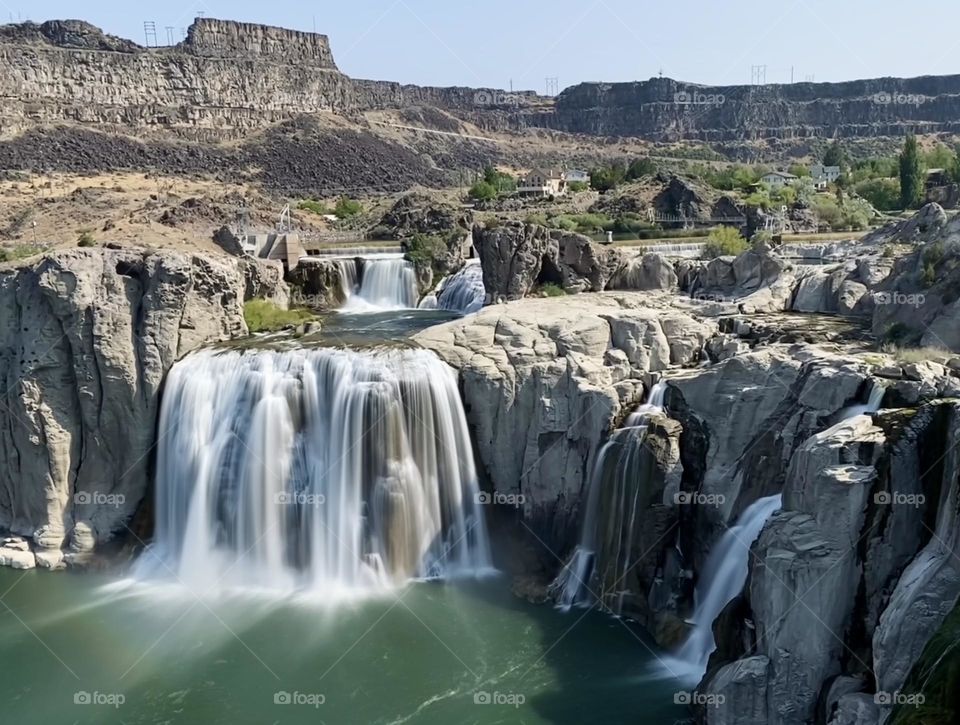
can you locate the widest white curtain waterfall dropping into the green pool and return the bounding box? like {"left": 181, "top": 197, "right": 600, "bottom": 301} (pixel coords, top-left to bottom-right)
{"left": 137, "top": 349, "right": 490, "bottom": 598}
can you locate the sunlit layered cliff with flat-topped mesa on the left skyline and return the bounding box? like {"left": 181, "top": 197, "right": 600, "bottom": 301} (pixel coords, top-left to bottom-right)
{"left": 0, "top": 18, "right": 535, "bottom": 137}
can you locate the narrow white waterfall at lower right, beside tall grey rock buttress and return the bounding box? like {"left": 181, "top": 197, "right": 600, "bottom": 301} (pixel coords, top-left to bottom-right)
{"left": 661, "top": 495, "right": 783, "bottom": 683}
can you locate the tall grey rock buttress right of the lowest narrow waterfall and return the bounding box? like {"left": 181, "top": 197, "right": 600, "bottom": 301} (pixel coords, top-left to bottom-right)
{"left": 701, "top": 402, "right": 960, "bottom": 725}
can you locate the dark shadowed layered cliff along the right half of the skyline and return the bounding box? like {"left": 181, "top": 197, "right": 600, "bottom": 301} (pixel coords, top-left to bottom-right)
{"left": 527, "top": 76, "right": 960, "bottom": 141}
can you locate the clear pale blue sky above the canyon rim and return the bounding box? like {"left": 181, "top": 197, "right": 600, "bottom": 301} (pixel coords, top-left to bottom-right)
{"left": 7, "top": 0, "right": 960, "bottom": 92}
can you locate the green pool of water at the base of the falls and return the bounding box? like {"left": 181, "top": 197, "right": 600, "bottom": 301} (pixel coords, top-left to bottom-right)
{"left": 0, "top": 569, "right": 688, "bottom": 725}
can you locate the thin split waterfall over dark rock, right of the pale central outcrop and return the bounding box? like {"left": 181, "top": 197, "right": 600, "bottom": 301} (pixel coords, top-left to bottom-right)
{"left": 550, "top": 382, "right": 667, "bottom": 611}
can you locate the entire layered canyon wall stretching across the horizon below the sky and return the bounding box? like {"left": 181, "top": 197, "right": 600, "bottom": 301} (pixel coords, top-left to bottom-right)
{"left": 0, "top": 18, "right": 960, "bottom": 142}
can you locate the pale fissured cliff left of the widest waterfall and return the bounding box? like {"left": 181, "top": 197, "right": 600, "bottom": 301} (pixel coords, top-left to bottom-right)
{"left": 0, "top": 249, "right": 286, "bottom": 564}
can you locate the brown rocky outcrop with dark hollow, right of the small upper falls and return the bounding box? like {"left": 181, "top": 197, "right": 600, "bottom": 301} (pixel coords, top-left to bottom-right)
{"left": 473, "top": 222, "right": 624, "bottom": 302}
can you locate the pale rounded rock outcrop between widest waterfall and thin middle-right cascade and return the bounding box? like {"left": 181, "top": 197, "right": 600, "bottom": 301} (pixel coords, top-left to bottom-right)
{"left": 414, "top": 293, "right": 716, "bottom": 551}
